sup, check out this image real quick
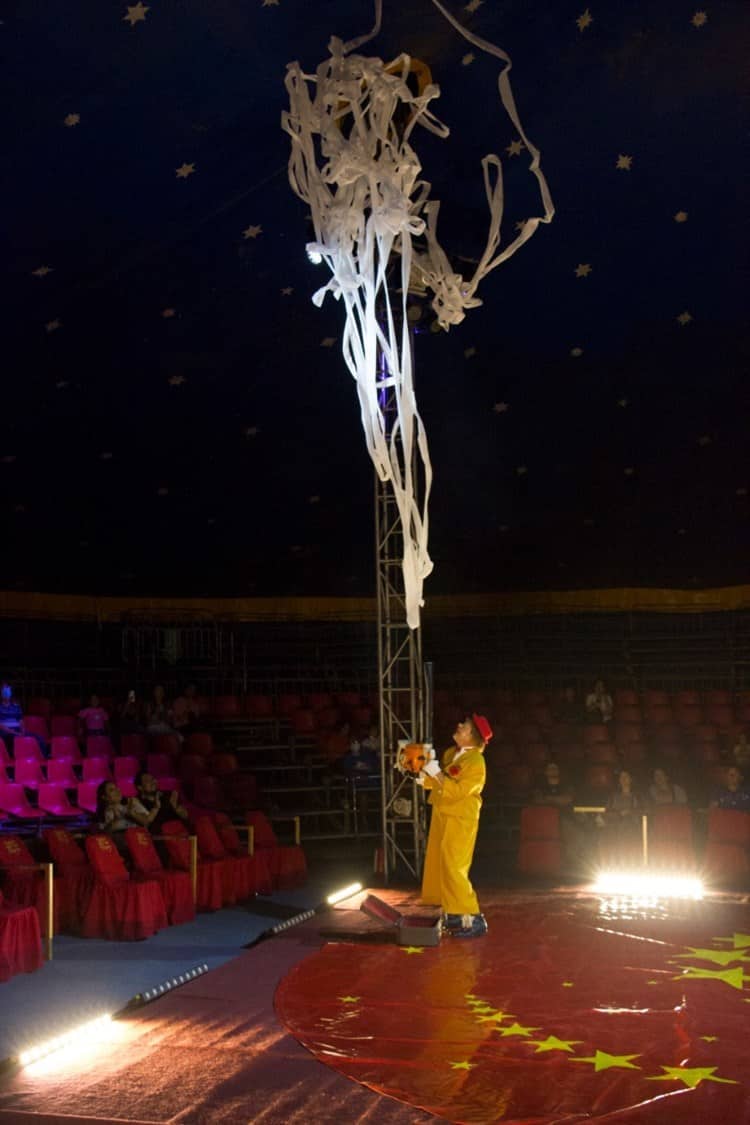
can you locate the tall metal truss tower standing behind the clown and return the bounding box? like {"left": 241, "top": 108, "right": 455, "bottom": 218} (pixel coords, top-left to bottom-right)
{"left": 374, "top": 337, "right": 428, "bottom": 883}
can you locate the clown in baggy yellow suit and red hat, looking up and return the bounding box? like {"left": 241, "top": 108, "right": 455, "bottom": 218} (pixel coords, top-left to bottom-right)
{"left": 422, "top": 714, "right": 493, "bottom": 937}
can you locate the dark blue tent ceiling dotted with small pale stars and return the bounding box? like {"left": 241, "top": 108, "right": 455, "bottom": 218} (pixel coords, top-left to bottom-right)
{"left": 0, "top": 0, "right": 750, "bottom": 597}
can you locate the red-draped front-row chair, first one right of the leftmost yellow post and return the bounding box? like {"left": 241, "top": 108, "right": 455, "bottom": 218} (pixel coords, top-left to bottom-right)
{"left": 82, "top": 833, "right": 169, "bottom": 942}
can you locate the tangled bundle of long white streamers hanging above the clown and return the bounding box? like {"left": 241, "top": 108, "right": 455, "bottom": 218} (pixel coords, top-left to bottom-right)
{"left": 282, "top": 0, "right": 553, "bottom": 629}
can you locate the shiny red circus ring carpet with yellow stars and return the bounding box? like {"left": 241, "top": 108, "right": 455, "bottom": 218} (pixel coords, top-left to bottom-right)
{"left": 275, "top": 892, "right": 750, "bottom": 1125}
